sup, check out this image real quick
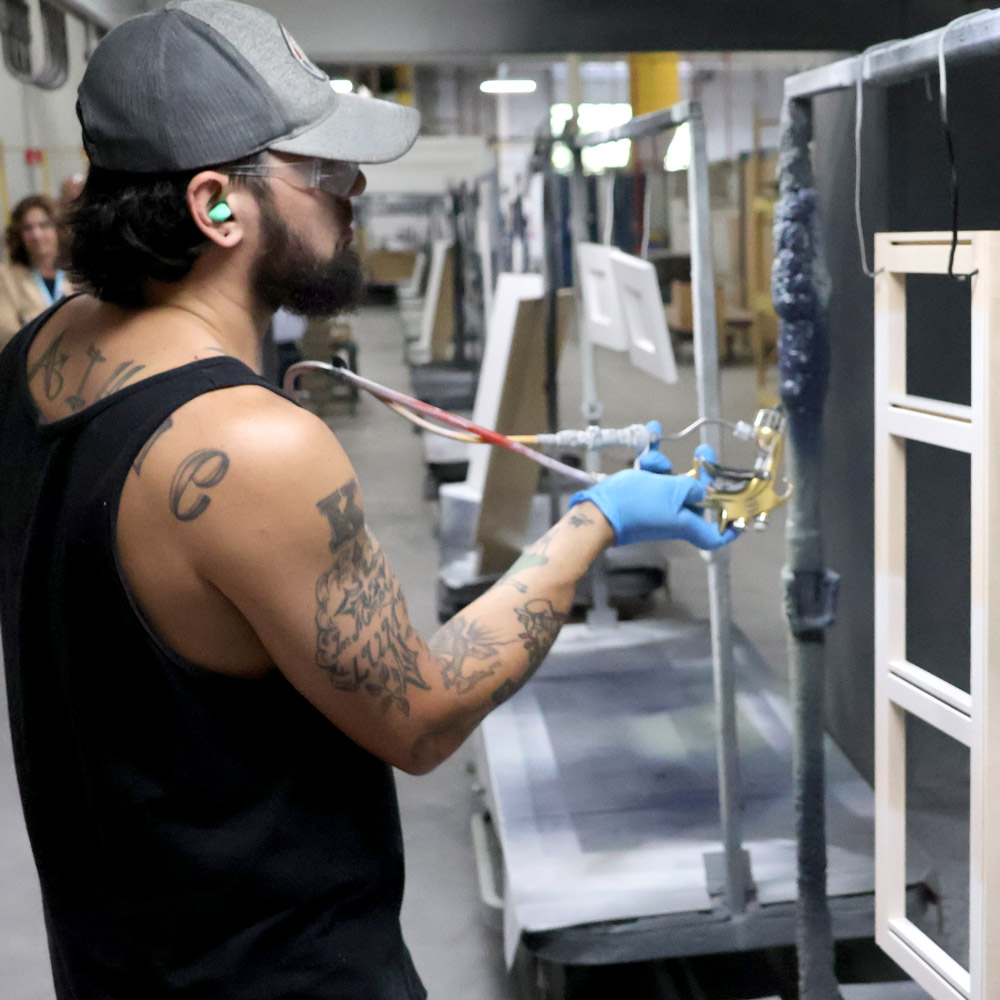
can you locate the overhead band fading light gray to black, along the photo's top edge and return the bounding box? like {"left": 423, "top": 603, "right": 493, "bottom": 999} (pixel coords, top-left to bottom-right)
{"left": 246, "top": 0, "right": 990, "bottom": 62}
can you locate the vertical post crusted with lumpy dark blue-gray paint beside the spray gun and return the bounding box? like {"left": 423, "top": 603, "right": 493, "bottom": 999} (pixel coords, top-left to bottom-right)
{"left": 771, "top": 95, "right": 840, "bottom": 1000}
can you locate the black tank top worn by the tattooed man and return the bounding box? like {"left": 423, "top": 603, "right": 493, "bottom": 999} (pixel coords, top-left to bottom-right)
{"left": 0, "top": 310, "right": 426, "bottom": 1000}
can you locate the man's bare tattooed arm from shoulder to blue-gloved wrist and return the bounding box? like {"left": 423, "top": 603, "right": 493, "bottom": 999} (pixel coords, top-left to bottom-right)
{"left": 132, "top": 389, "right": 614, "bottom": 773}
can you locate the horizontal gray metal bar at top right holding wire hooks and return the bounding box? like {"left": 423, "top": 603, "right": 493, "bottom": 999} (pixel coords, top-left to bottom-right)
{"left": 785, "top": 10, "right": 1000, "bottom": 100}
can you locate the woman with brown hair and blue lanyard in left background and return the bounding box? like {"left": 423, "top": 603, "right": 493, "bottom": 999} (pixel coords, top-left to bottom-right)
{"left": 0, "top": 195, "right": 75, "bottom": 348}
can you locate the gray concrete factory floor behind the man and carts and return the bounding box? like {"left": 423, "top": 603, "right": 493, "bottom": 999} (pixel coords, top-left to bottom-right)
{"left": 0, "top": 298, "right": 948, "bottom": 1000}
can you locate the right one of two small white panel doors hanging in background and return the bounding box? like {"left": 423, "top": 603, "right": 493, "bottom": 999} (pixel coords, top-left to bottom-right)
{"left": 612, "top": 253, "right": 677, "bottom": 385}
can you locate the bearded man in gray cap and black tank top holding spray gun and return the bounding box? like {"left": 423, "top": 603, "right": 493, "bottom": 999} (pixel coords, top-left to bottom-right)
{"left": 0, "top": 0, "right": 730, "bottom": 1000}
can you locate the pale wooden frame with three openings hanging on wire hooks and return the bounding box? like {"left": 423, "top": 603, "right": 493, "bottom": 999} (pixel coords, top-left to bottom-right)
{"left": 875, "top": 232, "right": 1000, "bottom": 1000}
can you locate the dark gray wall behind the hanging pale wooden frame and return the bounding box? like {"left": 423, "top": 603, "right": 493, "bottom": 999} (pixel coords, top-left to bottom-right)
{"left": 814, "top": 60, "right": 1000, "bottom": 779}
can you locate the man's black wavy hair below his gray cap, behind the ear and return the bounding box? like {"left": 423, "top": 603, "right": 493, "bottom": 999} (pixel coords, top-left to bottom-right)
{"left": 70, "top": 156, "right": 270, "bottom": 307}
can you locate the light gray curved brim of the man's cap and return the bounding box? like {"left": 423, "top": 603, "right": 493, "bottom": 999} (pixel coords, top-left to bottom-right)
{"left": 269, "top": 92, "right": 420, "bottom": 163}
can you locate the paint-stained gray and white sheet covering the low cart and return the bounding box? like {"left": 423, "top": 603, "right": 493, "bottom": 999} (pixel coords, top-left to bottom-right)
{"left": 478, "top": 622, "right": 908, "bottom": 961}
